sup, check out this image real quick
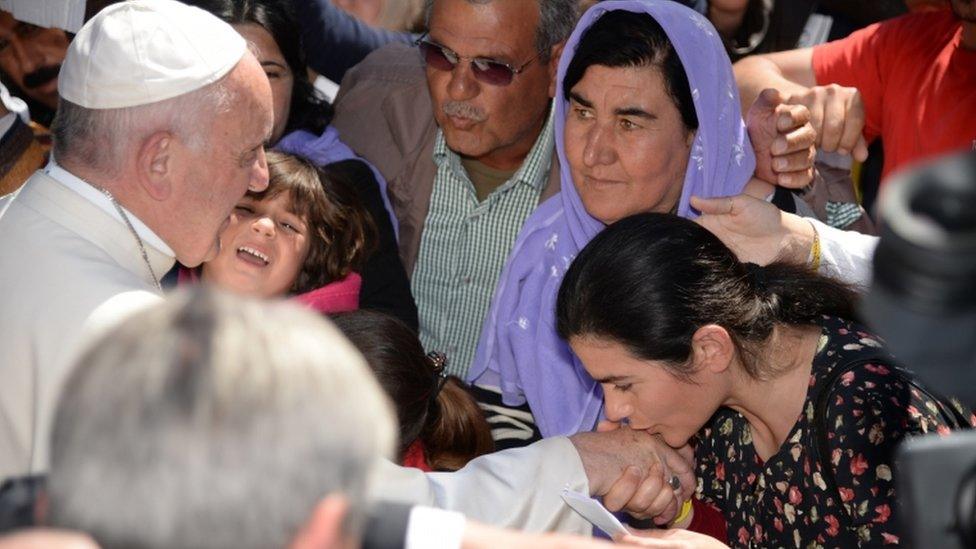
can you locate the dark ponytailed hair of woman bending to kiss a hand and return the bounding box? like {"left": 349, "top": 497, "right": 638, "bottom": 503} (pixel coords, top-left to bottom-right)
{"left": 556, "top": 213, "right": 856, "bottom": 379}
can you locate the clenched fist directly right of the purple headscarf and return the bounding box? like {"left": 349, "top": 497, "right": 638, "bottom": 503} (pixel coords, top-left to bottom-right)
{"left": 746, "top": 88, "right": 817, "bottom": 189}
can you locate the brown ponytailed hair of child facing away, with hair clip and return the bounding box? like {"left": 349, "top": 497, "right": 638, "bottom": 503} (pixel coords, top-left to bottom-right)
{"left": 332, "top": 310, "right": 494, "bottom": 471}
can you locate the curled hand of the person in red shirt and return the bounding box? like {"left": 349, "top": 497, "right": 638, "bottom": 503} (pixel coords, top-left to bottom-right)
{"left": 786, "top": 84, "right": 868, "bottom": 162}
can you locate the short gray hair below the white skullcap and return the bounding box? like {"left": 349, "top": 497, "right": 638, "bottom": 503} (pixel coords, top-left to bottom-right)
{"left": 51, "top": 76, "right": 235, "bottom": 175}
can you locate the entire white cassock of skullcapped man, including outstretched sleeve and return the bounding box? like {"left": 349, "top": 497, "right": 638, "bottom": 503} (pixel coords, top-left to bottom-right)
{"left": 0, "top": 165, "right": 590, "bottom": 534}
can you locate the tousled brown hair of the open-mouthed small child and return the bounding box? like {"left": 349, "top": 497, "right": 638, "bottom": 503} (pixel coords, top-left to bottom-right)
{"left": 247, "top": 151, "right": 377, "bottom": 293}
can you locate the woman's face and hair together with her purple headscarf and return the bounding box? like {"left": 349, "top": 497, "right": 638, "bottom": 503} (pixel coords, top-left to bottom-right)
{"left": 468, "top": 0, "right": 768, "bottom": 436}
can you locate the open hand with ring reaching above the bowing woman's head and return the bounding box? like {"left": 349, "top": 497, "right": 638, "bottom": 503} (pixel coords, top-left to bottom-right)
{"left": 691, "top": 194, "right": 815, "bottom": 265}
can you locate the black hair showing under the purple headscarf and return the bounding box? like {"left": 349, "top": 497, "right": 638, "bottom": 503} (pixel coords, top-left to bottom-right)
{"left": 563, "top": 10, "right": 698, "bottom": 131}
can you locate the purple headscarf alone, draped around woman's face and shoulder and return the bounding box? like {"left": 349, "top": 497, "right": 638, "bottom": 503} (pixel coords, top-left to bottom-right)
{"left": 468, "top": 0, "right": 755, "bottom": 437}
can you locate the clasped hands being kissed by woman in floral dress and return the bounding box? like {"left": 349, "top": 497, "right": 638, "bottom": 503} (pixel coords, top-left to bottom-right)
{"left": 573, "top": 422, "right": 696, "bottom": 524}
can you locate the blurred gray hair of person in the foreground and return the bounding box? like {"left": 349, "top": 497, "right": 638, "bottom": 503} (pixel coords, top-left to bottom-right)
{"left": 49, "top": 289, "right": 396, "bottom": 549}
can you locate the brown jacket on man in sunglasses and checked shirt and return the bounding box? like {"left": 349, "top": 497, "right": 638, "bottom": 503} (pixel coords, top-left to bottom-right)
{"left": 332, "top": 44, "right": 559, "bottom": 276}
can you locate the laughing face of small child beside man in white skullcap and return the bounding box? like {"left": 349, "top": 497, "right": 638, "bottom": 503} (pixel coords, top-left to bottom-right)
{"left": 203, "top": 192, "right": 309, "bottom": 297}
